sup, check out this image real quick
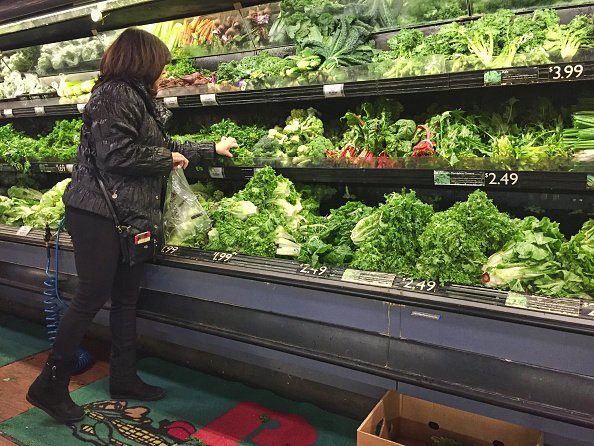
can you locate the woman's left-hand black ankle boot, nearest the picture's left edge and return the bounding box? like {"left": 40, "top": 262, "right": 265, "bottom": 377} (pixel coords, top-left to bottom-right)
{"left": 27, "top": 356, "right": 85, "bottom": 424}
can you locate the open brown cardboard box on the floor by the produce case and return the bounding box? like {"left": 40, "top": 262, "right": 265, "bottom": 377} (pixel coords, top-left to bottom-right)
{"left": 357, "top": 391, "right": 544, "bottom": 446}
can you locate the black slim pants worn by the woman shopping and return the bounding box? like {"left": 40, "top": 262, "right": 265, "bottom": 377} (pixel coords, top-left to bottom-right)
{"left": 53, "top": 207, "right": 143, "bottom": 377}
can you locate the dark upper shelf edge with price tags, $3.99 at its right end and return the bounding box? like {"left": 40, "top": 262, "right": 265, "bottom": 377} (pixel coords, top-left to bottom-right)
{"left": 0, "top": 61, "right": 594, "bottom": 118}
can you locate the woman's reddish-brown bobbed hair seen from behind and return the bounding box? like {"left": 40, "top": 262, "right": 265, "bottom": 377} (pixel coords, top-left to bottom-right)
{"left": 97, "top": 28, "right": 171, "bottom": 91}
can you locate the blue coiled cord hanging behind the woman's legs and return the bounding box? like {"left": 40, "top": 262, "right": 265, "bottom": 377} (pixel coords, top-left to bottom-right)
{"left": 43, "top": 219, "right": 94, "bottom": 373}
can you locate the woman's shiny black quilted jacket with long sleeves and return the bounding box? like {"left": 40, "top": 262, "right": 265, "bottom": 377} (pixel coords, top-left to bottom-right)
{"left": 63, "top": 80, "right": 215, "bottom": 237}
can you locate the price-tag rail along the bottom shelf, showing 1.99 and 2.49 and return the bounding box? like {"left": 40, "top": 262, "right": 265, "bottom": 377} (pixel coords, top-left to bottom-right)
{"left": 0, "top": 225, "right": 594, "bottom": 335}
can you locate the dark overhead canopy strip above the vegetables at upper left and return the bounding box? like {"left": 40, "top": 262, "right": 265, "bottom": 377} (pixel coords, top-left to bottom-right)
{"left": 0, "top": 0, "right": 269, "bottom": 51}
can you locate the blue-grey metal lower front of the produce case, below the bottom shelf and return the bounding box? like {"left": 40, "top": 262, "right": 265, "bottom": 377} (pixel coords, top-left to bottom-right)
{"left": 0, "top": 230, "right": 594, "bottom": 428}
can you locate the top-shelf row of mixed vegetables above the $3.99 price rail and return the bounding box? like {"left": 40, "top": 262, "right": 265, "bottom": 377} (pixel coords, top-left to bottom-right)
{"left": 0, "top": 0, "right": 594, "bottom": 98}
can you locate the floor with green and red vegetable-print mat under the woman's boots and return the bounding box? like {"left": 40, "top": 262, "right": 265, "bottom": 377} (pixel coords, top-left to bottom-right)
{"left": 0, "top": 314, "right": 360, "bottom": 446}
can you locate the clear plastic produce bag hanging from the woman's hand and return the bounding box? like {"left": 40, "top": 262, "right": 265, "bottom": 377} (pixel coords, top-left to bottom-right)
{"left": 163, "top": 169, "right": 211, "bottom": 246}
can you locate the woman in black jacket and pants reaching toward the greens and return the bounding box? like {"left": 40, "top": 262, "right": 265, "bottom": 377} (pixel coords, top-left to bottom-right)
{"left": 27, "top": 29, "right": 237, "bottom": 423}
